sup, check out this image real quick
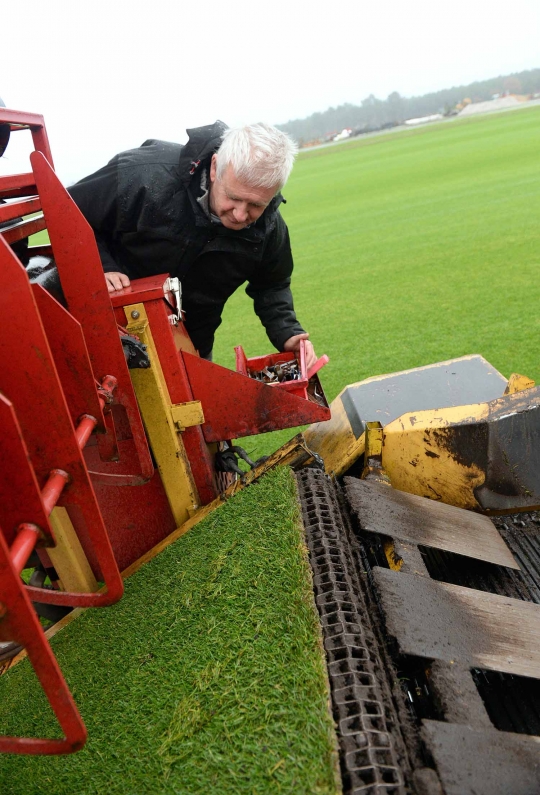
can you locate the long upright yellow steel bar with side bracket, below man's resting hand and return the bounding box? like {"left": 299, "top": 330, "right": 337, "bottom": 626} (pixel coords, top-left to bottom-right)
{"left": 124, "top": 304, "right": 200, "bottom": 525}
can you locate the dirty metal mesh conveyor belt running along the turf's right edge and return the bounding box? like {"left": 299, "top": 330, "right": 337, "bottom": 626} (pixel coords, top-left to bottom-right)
{"left": 296, "top": 469, "right": 410, "bottom": 795}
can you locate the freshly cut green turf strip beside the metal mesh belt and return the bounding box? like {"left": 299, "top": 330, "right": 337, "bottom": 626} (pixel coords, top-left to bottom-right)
{"left": 0, "top": 468, "right": 340, "bottom": 795}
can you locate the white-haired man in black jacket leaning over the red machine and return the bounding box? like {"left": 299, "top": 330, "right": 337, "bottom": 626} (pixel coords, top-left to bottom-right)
{"left": 69, "top": 121, "right": 316, "bottom": 367}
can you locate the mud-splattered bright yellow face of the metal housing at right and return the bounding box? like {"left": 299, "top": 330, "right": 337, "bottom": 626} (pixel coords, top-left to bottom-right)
{"left": 383, "top": 403, "right": 489, "bottom": 510}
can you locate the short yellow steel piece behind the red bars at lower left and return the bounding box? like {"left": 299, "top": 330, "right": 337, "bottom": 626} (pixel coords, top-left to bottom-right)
{"left": 47, "top": 507, "right": 99, "bottom": 593}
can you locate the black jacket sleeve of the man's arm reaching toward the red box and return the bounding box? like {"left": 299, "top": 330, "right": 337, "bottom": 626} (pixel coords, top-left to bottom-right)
{"left": 246, "top": 216, "right": 304, "bottom": 351}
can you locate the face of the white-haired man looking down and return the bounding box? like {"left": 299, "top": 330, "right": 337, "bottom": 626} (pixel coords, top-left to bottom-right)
{"left": 210, "top": 155, "right": 278, "bottom": 229}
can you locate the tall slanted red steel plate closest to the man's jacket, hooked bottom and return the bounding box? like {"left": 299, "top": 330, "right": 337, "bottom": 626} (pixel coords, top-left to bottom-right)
{"left": 30, "top": 152, "right": 154, "bottom": 484}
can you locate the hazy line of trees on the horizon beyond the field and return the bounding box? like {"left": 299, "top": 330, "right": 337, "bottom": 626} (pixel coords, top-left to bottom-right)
{"left": 277, "top": 69, "right": 540, "bottom": 145}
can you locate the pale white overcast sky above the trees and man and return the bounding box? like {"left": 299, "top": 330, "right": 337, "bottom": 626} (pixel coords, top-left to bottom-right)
{"left": 0, "top": 0, "right": 540, "bottom": 184}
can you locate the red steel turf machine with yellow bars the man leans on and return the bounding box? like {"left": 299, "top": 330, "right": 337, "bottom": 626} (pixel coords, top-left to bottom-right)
{"left": 0, "top": 108, "right": 330, "bottom": 754}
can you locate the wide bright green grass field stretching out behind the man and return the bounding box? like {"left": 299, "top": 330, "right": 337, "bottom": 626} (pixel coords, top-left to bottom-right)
{"left": 215, "top": 103, "right": 540, "bottom": 453}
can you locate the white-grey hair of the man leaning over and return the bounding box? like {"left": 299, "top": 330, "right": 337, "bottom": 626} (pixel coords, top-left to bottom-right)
{"left": 216, "top": 123, "right": 298, "bottom": 191}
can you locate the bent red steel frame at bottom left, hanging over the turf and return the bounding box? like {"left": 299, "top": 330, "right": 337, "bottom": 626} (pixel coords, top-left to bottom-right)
{"left": 0, "top": 529, "right": 87, "bottom": 754}
